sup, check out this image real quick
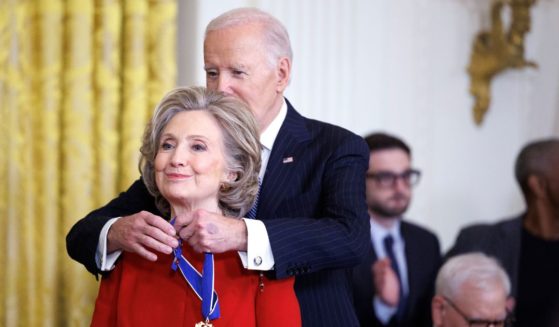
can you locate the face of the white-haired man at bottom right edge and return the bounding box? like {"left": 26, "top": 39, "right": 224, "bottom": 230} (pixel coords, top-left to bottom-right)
{"left": 432, "top": 285, "right": 507, "bottom": 327}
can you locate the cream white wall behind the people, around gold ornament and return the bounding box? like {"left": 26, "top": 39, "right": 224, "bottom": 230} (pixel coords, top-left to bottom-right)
{"left": 178, "top": 0, "right": 559, "bottom": 249}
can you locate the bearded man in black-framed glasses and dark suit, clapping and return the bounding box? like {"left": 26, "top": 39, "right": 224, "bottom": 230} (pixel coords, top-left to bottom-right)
{"left": 353, "top": 133, "right": 441, "bottom": 327}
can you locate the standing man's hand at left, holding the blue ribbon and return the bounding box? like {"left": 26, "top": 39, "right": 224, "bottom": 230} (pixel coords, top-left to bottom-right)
{"left": 107, "top": 211, "right": 179, "bottom": 261}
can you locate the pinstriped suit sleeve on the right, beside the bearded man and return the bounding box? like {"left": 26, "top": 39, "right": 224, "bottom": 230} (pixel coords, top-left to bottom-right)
{"left": 264, "top": 133, "right": 371, "bottom": 278}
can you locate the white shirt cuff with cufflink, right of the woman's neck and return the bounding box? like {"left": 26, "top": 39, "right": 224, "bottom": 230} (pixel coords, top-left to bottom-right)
{"left": 239, "top": 218, "right": 275, "bottom": 271}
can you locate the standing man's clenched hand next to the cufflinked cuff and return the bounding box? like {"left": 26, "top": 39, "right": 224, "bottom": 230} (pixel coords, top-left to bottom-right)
{"left": 175, "top": 209, "right": 247, "bottom": 253}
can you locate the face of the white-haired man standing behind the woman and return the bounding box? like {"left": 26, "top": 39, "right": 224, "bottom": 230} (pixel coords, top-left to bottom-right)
{"left": 204, "top": 24, "right": 290, "bottom": 130}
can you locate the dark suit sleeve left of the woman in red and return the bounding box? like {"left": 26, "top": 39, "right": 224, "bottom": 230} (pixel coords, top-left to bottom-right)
{"left": 66, "top": 179, "right": 159, "bottom": 276}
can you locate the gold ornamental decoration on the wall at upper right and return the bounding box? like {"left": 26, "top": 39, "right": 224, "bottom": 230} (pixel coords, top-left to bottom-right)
{"left": 468, "top": 0, "right": 537, "bottom": 125}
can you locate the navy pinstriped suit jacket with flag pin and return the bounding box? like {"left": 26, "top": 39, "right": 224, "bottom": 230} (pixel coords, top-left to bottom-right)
{"left": 66, "top": 102, "right": 371, "bottom": 326}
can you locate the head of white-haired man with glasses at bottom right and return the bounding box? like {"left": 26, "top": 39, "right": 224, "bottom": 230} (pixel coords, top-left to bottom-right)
{"left": 431, "top": 253, "right": 516, "bottom": 327}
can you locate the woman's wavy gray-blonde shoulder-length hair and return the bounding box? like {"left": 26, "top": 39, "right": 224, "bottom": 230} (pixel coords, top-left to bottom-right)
{"left": 139, "top": 87, "right": 261, "bottom": 217}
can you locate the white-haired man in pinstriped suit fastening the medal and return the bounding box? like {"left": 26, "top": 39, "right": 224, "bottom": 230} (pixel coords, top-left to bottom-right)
{"left": 66, "top": 8, "right": 371, "bottom": 326}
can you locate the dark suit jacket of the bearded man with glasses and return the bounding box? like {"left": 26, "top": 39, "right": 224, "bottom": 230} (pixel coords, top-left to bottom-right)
{"left": 353, "top": 221, "right": 441, "bottom": 327}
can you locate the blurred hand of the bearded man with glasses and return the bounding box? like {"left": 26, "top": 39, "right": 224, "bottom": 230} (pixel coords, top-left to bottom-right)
{"left": 371, "top": 258, "right": 400, "bottom": 307}
